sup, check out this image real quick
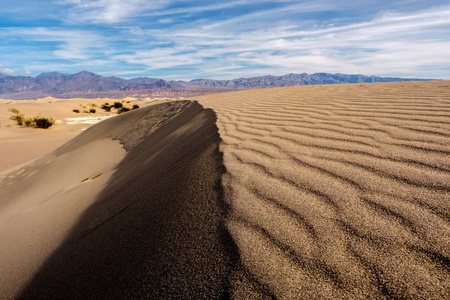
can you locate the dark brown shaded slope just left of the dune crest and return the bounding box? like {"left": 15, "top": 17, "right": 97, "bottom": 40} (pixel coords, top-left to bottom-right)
{"left": 19, "top": 101, "right": 238, "bottom": 299}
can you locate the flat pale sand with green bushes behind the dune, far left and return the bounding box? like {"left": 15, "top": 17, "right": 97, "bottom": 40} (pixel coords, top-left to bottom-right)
{"left": 0, "top": 97, "right": 169, "bottom": 172}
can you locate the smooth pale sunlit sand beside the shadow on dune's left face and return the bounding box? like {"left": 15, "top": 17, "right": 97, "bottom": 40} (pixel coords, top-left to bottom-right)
{"left": 0, "top": 139, "right": 125, "bottom": 297}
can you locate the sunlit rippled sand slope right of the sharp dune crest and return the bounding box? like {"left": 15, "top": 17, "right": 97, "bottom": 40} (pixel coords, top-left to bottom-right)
{"left": 196, "top": 81, "right": 450, "bottom": 299}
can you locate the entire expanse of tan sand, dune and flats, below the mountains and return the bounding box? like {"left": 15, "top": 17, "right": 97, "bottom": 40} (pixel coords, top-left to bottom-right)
{"left": 0, "top": 81, "right": 450, "bottom": 299}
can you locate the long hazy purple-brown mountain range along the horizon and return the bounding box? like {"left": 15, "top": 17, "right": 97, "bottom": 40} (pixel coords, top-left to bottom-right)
{"left": 0, "top": 71, "right": 427, "bottom": 99}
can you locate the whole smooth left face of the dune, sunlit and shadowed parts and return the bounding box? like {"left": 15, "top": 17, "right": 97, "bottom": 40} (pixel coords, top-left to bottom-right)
{"left": 0, "top": 101, "right": 238, "bottom": 299}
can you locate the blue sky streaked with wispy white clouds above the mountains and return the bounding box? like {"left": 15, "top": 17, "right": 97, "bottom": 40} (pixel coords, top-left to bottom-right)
{"left": 0, "top": 0, "right": 450, "bottom": 80}
